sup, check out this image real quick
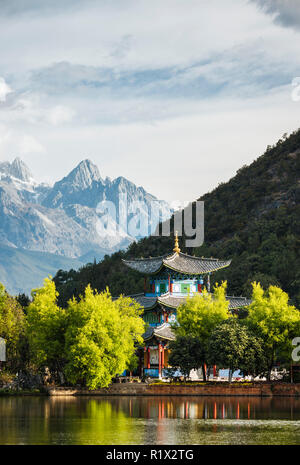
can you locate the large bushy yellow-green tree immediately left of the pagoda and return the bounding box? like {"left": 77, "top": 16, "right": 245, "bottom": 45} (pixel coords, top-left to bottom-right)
{"left": 65, "top": 286, "right": 144, "bottom": 389}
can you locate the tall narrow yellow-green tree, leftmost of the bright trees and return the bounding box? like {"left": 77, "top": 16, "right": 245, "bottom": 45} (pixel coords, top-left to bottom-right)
{"left": 27, "top": 278, "right": 66, "bottom": 371}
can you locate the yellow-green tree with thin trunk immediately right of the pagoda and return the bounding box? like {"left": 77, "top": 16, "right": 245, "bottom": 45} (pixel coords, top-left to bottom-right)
{"left": 174, "top": 282, "right": 229, "bottom": 380}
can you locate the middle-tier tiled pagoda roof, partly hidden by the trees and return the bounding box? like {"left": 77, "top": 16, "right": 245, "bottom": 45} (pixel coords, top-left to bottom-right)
{"left": 129, "top": 292, "right": 252, "bottom": 310}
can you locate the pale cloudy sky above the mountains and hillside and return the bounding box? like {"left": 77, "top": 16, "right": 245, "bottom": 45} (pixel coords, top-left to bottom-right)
{"left": 0, "top": 0, "right": 300, "bottom": 201}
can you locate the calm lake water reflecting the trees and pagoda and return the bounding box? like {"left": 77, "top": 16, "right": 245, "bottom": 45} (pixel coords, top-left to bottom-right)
{"left": 0, "top": 397, "right": 300, "bottom": 445}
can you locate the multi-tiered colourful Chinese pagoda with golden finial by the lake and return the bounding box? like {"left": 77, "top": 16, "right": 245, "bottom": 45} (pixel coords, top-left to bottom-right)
{"left": 123, "top": 234, "right": 250, "bottom": 377}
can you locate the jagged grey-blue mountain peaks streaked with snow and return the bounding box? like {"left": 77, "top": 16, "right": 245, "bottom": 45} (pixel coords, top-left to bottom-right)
{"left": 0, "top": 158, "right": 170, "bottom": 259}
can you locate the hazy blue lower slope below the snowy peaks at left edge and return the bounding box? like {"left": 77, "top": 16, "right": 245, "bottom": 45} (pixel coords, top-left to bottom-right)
{"left": 0, "top": 245, "right": 82, "bottom": 295}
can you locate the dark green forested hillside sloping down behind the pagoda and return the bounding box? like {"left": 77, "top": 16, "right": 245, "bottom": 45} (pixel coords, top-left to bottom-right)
{"left": 55, "top": 130, "right": 300, "bottom": 304}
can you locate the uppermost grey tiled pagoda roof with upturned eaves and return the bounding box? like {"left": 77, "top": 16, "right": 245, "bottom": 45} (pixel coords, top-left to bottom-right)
{"left": 123, "top": 252, "right": 231, "bottom": 275}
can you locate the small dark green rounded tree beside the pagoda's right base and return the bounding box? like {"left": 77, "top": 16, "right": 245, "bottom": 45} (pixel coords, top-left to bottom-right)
{"left": 169, "top": 336, "right": 204, "bottom": 379}
